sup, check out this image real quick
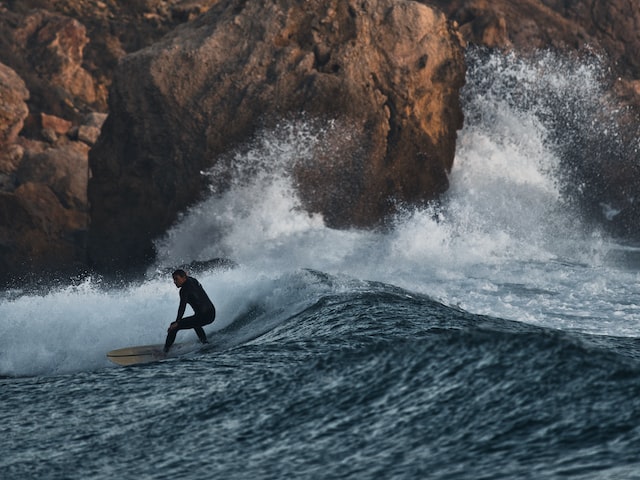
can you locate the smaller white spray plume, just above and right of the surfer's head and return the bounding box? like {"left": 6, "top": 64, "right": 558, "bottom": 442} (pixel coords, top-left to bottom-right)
{"left": 151, "top": 121, "right": 331, "bottom": 265}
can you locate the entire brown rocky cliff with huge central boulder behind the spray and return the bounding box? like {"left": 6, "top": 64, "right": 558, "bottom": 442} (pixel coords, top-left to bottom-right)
{"left": 0, "top": 0, "right": 640, "bottom": 277}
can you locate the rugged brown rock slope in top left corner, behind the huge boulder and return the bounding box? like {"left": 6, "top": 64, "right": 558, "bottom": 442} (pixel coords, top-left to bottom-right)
{"left": 0, "top": 0, "right": 218, "bottom": 122}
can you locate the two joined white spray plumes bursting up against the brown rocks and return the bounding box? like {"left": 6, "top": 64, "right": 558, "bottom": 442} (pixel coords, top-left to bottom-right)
{"left": 156, "top": 52, "right": 620, "bottom": 271}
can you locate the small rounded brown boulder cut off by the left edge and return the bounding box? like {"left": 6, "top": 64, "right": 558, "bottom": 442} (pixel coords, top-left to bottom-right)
{"left": 0, "top": 63, "right": 29, "bottom": 149}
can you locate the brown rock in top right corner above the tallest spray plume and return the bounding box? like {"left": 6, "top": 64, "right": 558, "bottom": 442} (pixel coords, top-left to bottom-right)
{"left": 429, "top": 0, "right": 640, "bottom": 78}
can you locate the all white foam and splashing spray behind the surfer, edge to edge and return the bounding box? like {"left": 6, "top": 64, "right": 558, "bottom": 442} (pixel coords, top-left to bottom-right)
{"left": 0, "top": 50, "right": 640, "bottom": 374}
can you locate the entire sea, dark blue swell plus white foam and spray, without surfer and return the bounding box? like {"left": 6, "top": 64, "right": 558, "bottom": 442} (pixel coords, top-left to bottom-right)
{"left": 0, "top": 53, "right": 640, "bottom": 479}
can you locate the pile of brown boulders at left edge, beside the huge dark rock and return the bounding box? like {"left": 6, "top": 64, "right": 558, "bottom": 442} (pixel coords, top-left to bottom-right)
{"left": 0, "top": 4, "right": 104, "bottom": 283}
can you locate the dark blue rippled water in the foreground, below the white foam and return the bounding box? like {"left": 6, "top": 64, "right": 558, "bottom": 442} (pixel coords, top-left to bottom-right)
{"left": 0, "top": 279, "right": 640, "bottom": 479}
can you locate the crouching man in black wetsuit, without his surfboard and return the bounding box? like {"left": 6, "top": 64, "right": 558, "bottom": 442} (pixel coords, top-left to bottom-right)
{"left": 164, "top": 270, "right": 216, "bottom": 353}
